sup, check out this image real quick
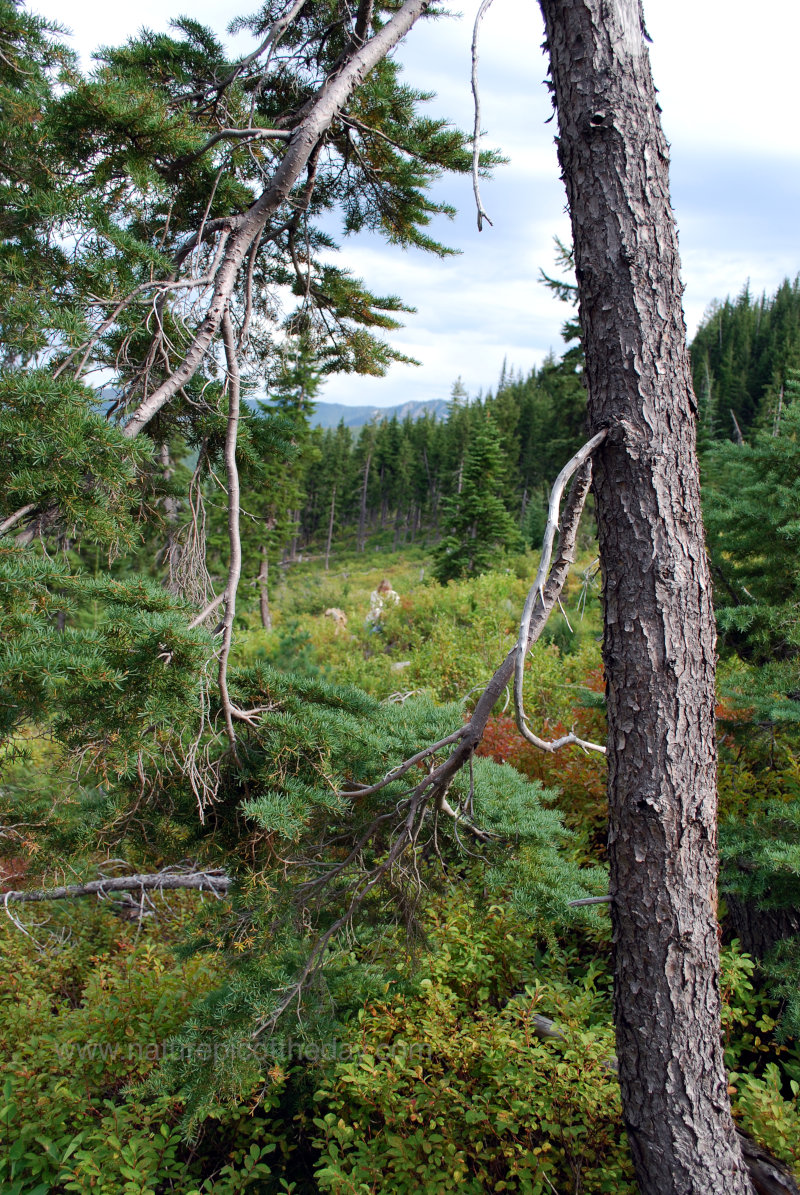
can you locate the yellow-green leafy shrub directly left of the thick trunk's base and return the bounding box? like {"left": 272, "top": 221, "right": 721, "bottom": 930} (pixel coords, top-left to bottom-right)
{"left": 314, "top": 906, "right": 636, "bottom": 1195}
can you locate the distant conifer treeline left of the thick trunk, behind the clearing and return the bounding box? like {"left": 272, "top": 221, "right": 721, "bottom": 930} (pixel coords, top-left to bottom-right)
{"left": 292, "top": 350, "right": 586, "bottom": 547}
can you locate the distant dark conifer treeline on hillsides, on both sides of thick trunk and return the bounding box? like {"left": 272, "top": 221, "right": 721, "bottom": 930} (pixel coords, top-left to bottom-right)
{"left": 271, "top": 277, "right": 800, "bottom": 559}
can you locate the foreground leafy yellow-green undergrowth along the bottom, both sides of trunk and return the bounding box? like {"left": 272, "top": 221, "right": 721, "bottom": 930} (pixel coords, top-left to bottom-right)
{"left": 0, "top": 883, "right": 800, "bottom": 1195}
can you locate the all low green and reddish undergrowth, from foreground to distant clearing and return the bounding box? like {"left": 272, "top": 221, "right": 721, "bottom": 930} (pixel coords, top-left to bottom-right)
{"left": 0, "top": 554, "right": 800, "bottom": 1195}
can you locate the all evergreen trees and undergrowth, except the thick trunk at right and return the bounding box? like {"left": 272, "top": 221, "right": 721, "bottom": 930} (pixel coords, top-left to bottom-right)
{"left": 0, "top": 0, "right": 800, "bottom": 1195}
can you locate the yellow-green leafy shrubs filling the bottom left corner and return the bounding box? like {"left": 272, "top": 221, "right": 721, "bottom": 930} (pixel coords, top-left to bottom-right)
{"left": 0, "top": 897, "right": 298, "bottom": 1195}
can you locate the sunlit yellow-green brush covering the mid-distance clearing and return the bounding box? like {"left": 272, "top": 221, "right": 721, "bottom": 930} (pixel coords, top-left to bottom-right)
{"left": 237, "top": 553, "right": 599, "bottom": 702}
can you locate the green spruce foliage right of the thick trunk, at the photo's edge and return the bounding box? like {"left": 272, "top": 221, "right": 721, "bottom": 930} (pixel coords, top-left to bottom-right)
{"left": 703, "top": 372, "right": 800, "bottom": 1035}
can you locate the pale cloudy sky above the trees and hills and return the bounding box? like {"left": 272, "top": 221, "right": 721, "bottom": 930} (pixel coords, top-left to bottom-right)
{"left": 30, "top": 0, "right": 800, "bottom": 406}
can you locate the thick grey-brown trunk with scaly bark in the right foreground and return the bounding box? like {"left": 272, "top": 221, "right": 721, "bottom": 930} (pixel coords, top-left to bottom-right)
{"left": 541, "top": 0, "right": 751, "bottom": 1195}
